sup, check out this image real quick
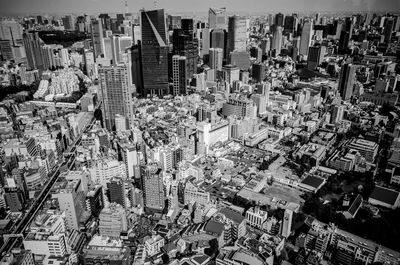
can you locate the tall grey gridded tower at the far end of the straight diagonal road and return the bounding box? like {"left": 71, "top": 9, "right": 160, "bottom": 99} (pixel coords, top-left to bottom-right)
{"left": 99, "top": 63, "right": 134, "bottom": 130}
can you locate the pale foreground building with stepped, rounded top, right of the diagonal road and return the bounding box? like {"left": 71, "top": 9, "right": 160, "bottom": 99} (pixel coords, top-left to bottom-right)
{"left": 99, "top": 203, "right": 128, "bottom": 238}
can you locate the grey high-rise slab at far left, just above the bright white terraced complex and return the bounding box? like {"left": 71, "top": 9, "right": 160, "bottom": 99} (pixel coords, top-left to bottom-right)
{"left": 23, "top": 32, "right": 44, "bottom": 70}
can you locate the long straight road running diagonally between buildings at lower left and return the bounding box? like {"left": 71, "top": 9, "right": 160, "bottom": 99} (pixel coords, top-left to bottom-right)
{"left": 0, "top": 102, "right": 101, "bottom": 260}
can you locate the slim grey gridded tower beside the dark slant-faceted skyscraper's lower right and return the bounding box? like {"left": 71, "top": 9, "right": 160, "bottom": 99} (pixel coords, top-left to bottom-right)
{"left": 172, "top": 55, "right": 187, "bottom": 95}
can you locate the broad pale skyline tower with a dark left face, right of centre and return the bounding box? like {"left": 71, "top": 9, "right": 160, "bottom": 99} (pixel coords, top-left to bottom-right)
{"left": 228, "top": 15, "right": 247, "bottom": 53}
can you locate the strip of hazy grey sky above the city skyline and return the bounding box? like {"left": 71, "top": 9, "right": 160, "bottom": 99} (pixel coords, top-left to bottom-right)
{"left": 0, "top": 0, "right": 400, "bottom": 14}
